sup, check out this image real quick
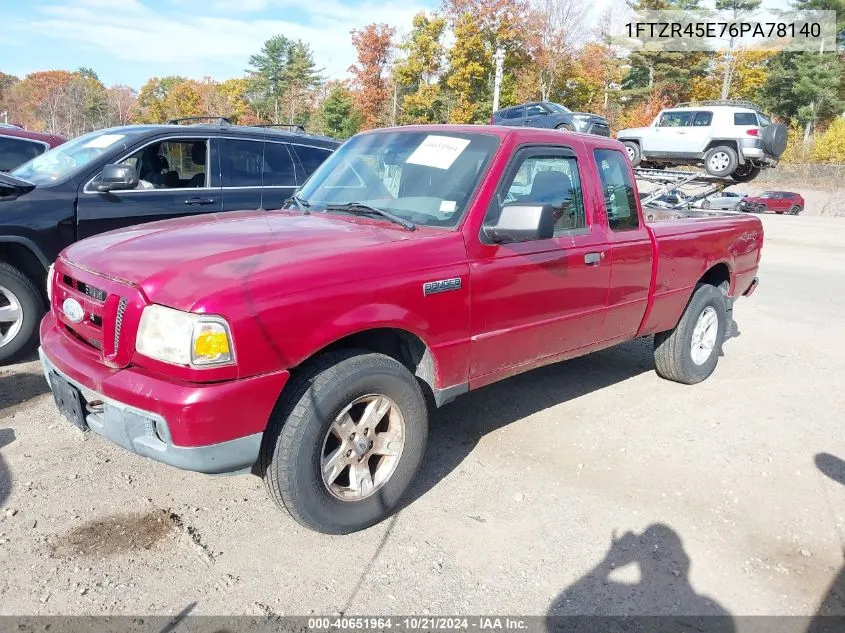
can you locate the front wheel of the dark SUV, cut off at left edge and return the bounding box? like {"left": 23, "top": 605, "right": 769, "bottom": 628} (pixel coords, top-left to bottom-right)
{"left": 0, "top": 263, "right": 44, "bottom": 364}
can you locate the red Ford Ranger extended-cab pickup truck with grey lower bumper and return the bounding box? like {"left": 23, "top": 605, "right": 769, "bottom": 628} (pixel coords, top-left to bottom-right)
{"left": 40, "top": 125, "right": 763, "bottom": 534}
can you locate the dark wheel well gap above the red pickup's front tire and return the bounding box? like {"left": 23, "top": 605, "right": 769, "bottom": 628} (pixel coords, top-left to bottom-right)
{"left": 319, "top": 328, "right": 436, "bottom": 398}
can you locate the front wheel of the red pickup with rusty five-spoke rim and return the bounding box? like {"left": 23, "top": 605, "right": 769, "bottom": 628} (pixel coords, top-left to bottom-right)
{"left": 260, "top": 350, "right": 428, "bottom": 534}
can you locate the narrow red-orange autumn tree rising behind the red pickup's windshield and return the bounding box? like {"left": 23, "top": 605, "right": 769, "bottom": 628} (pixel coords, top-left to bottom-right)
{"left": 349, "top": 24, "right": 395, "bottom": 130}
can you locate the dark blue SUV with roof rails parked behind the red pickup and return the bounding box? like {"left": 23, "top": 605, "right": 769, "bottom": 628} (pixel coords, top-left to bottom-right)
{"left": 0, "top": 117, "right": 340, "bottom": 362}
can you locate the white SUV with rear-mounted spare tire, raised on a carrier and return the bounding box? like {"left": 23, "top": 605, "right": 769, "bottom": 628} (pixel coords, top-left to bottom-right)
{"left": 616, "top": 101, "right": 787, "bottom": 182}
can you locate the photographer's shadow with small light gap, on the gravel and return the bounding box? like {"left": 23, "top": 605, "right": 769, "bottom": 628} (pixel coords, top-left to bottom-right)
{"left": 546, "top": 523, "right": 736, "bottom": 633}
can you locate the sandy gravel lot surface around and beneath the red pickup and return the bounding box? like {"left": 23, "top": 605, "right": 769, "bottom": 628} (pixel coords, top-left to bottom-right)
{"left": 0, "top": 216, "right": 845, "bottom": 615}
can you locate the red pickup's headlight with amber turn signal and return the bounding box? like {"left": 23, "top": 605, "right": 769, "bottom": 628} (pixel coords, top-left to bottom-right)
{"left": 135, "top": 305, "right": 234, "bottom": 367}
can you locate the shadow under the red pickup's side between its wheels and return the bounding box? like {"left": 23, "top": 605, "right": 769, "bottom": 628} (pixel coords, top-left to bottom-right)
{"left": 403, "top": 337, "right": 654, "bottom": 506}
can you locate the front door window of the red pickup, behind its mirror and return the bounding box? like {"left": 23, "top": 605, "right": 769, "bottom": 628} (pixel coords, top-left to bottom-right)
{"left": 499, "top": 154, "right": 587, "bottom": 235}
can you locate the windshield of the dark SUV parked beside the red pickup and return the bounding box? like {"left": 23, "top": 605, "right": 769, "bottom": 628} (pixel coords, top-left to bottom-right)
{"left": 11, "top": 130, "right": 138, "bottom": 185}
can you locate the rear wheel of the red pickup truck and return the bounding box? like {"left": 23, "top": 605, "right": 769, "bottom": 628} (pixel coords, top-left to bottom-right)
{"left": 654, "top": 284, "right": 728, "bottom": 385}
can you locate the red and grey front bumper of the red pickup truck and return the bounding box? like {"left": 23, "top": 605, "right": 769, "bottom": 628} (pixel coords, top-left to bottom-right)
{"left": 38, "top": 314, "right": 288, "bottom": 474}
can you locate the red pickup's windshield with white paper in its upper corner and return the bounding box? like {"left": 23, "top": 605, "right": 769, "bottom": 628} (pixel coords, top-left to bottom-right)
{"left": 291, "top": 131, "right": 499, "bottom": 227}
